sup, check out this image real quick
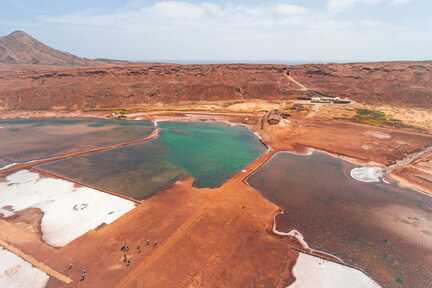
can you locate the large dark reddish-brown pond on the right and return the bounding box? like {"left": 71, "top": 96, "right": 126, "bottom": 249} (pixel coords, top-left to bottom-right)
{"left": 248, "top": 152, "right": 432, "bottom": 288}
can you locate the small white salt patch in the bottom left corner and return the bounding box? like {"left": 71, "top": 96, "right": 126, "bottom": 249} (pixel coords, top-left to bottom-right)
{"left": 0, "top": 247, "right": 49, "bottom": 288}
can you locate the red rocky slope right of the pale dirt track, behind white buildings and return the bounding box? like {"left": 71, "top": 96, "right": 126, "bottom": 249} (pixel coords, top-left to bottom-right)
{"left": 289, "top": 61, "right": 432, "bottom": 108}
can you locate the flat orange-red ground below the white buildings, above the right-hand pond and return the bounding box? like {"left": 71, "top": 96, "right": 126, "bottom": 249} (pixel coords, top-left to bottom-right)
{"left": 262, "top": 118, "right": 432, "bottom": 165}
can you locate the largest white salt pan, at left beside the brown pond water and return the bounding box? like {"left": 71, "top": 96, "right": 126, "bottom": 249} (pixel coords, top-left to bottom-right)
{"left": 0, "top": 170, "right": 135, "bottom": 247}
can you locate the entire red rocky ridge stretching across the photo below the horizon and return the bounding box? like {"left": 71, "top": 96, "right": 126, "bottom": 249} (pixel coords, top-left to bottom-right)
{"left": 0, "top": 62, "right": 432, "bottom": 111}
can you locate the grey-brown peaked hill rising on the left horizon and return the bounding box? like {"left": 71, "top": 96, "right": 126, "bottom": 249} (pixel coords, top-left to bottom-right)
{"left": 0, "top": 31, "right": 95, "bottom": 66}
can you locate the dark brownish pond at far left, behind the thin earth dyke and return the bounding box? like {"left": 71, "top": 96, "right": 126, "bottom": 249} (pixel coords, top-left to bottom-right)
{"left": 0, "top": 118, "right": 154, "bottom": 167}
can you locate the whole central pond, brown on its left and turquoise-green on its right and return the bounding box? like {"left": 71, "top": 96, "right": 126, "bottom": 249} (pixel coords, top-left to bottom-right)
{"left": 42, "top": 122, "right": 265, "bottom": 199}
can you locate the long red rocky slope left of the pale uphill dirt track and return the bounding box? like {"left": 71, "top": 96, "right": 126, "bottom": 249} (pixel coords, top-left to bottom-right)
{"left": 0, "top": 64, "right": 298, "bottom": 110}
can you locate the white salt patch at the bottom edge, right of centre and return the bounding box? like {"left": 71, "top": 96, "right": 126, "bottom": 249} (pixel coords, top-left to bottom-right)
{"left": 289, "top": 253, "right": 380, "bottom": 288}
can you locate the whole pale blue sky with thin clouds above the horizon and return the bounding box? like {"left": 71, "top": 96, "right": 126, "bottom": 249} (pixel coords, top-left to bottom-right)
{"left": 0, "top": 0, "right": 432, "bottom": 62}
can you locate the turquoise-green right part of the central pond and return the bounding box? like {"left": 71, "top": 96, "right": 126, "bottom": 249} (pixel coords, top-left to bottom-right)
{"left": 160, "top": 122, "right": 265, "bottom": 187}
